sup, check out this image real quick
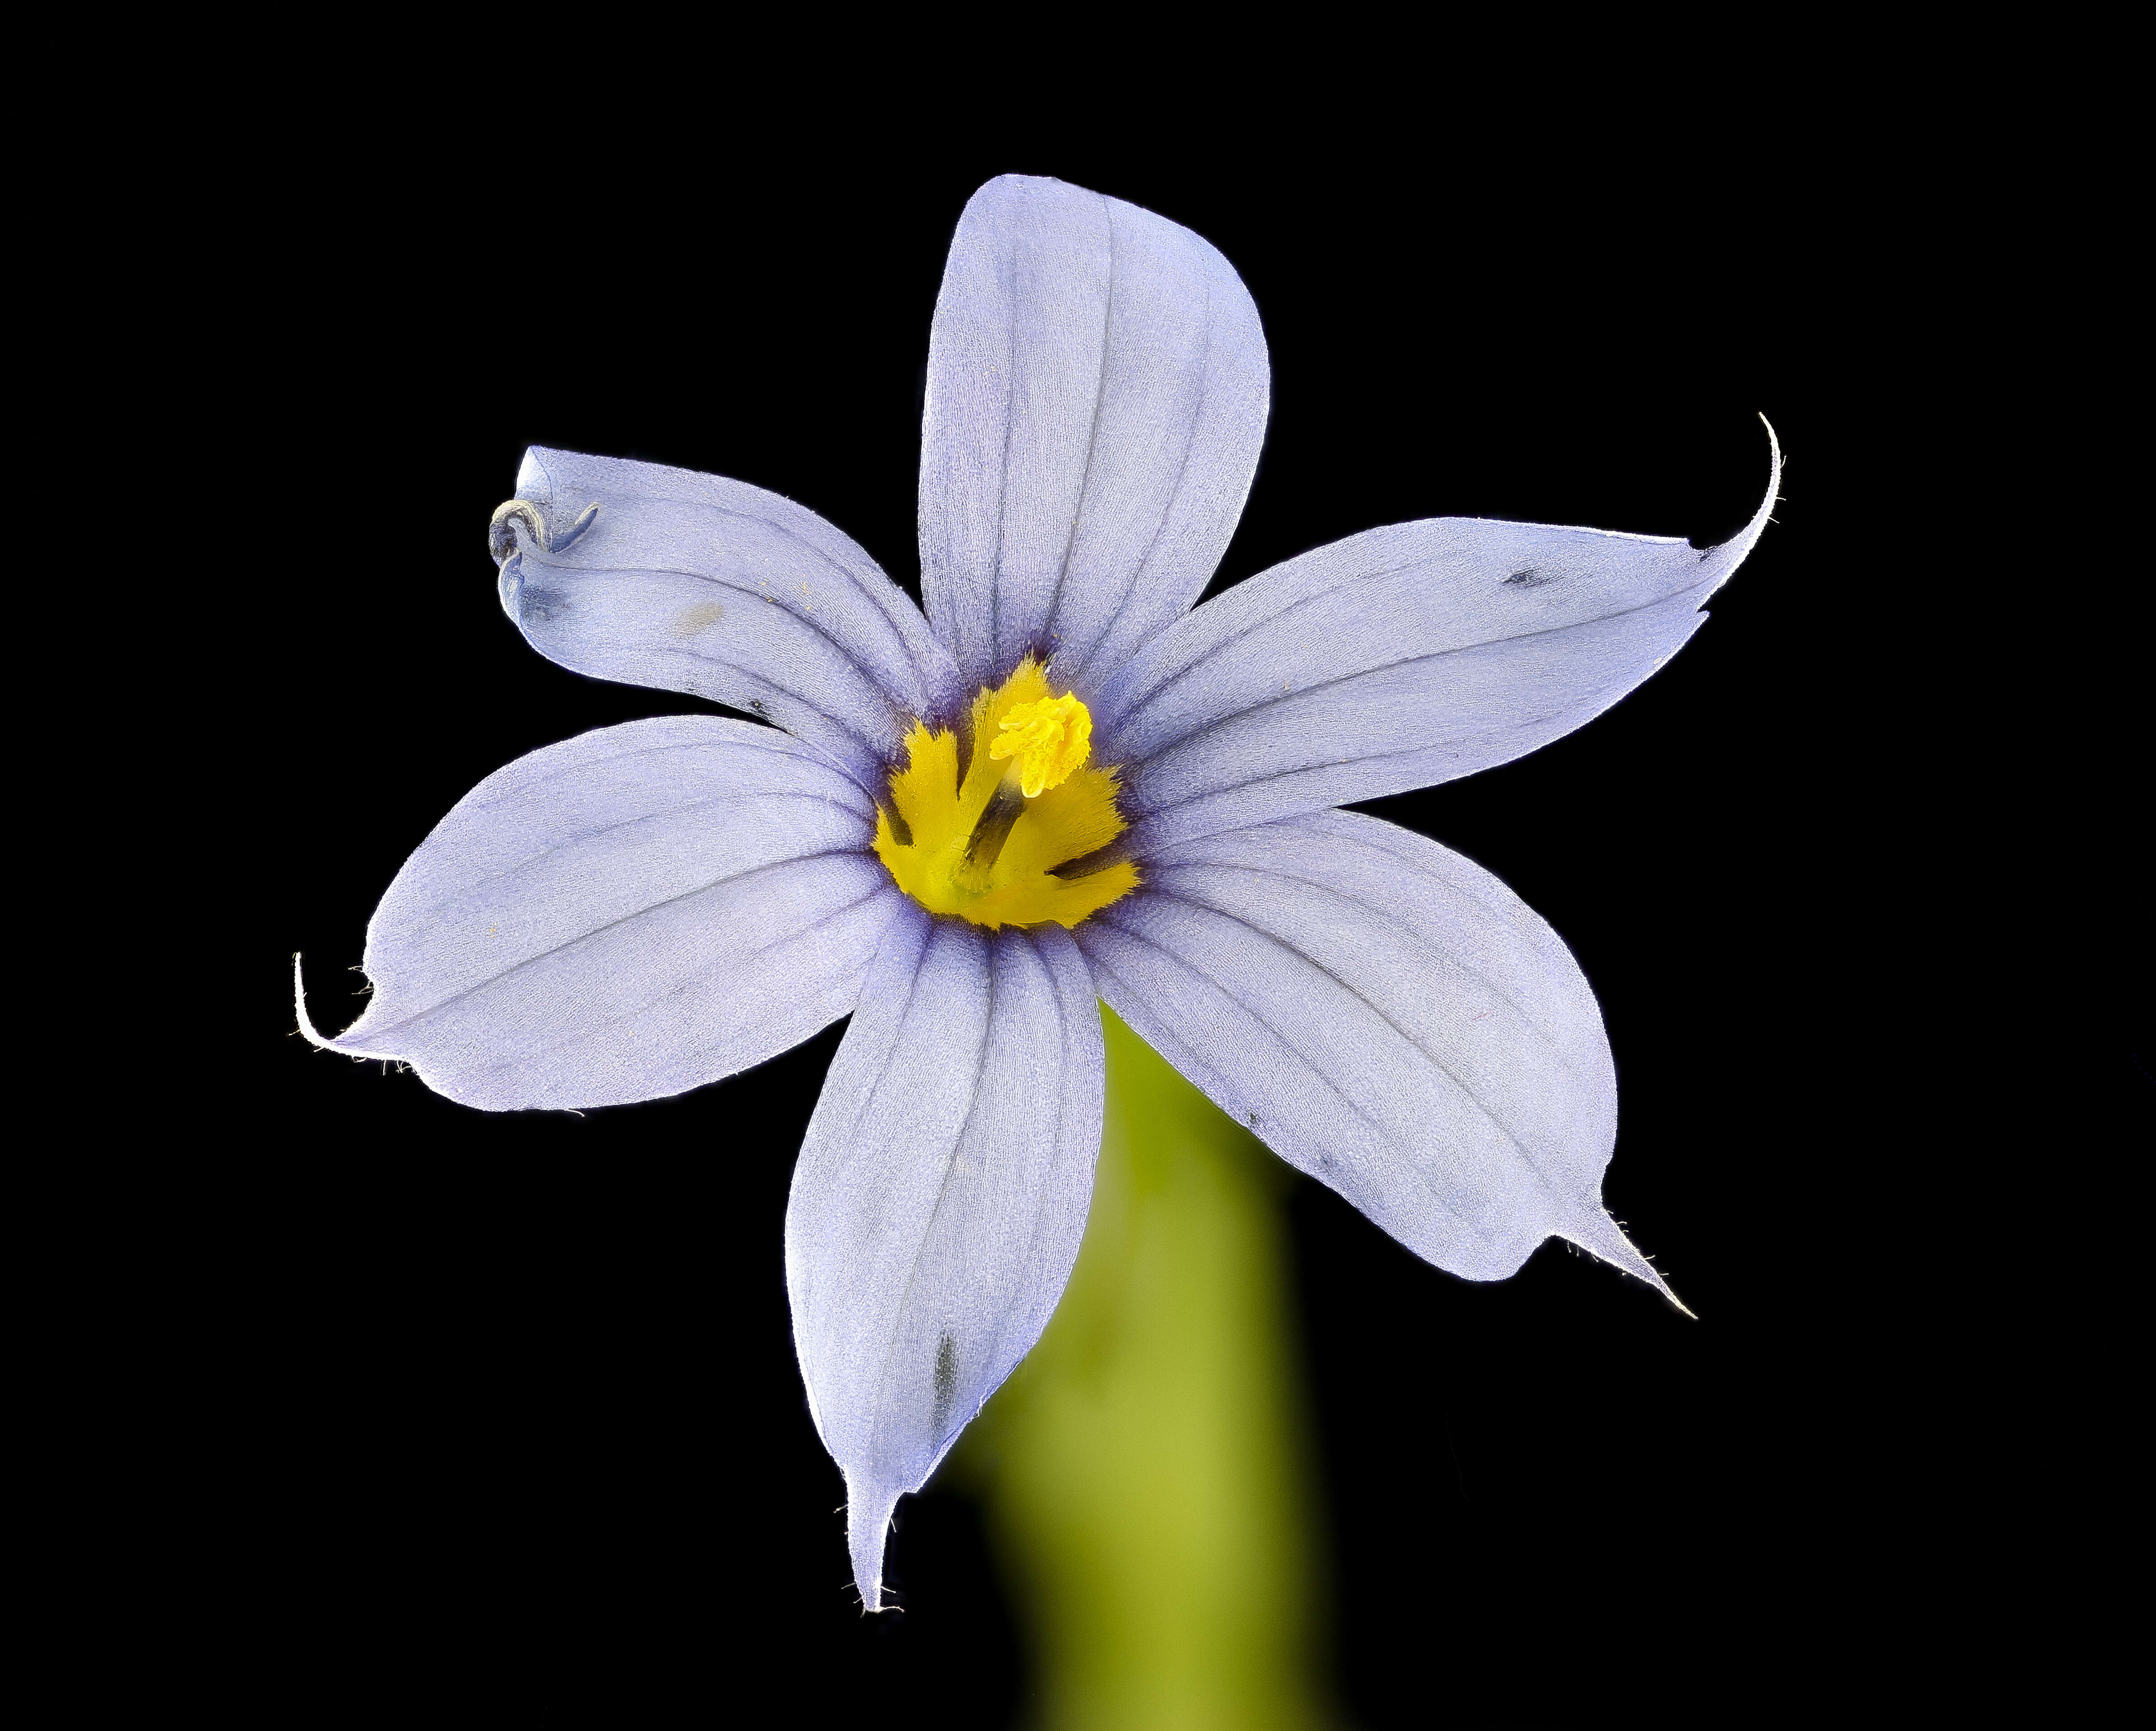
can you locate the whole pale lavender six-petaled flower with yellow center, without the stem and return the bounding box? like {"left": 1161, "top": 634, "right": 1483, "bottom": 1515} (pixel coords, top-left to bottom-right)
{"left": 302, "top": 177, "right": 1781, "bottom": 1608}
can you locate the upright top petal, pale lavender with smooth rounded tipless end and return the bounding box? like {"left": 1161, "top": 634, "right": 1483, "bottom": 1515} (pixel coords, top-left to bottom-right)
{"left": 921, "top": 174, "right": 1272, "bottom": 694}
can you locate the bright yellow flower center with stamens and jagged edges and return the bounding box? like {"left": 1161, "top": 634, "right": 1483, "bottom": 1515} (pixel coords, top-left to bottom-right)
{"left": 875, "top": 655, "right": 1138, "bottom": 929}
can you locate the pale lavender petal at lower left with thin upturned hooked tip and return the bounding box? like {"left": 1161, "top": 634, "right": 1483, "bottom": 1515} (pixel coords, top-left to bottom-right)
{"left": 306, "top": 716, "right": 903, "bottom": 1110}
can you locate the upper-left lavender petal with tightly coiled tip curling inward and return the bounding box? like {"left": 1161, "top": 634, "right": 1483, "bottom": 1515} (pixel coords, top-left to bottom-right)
{"left": 489, "top": 449, "right": 959, "bottom": 789}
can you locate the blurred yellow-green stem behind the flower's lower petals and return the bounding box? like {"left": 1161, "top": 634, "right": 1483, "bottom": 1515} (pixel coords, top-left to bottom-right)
{"left": 962, "top": 1007, "right": 1330, "bottom": 1731}
